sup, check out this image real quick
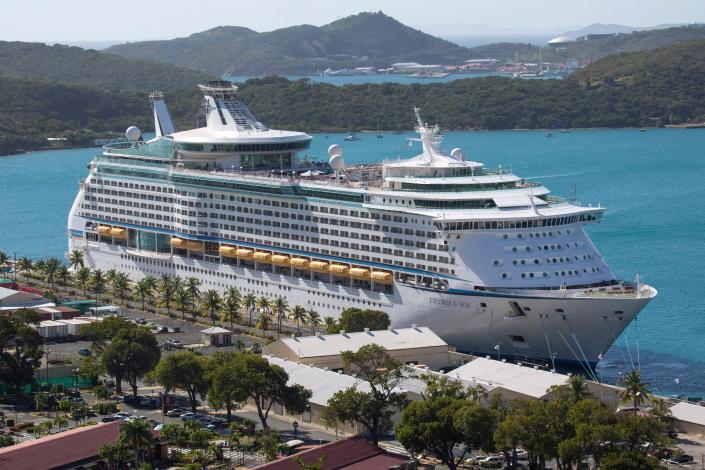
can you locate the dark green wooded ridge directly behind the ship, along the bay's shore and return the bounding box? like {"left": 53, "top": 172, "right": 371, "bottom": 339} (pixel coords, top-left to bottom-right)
{"left": 0, "top": 40, "right": 705, "bottom": 154}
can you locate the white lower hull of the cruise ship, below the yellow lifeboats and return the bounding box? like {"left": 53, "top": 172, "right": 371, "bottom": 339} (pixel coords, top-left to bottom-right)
{"left": 69, "top": 235, "right": 656, "bottom": 366}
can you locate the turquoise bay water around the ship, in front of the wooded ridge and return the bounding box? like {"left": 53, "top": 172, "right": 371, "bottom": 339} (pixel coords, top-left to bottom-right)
{"left": 0, "top": 129, "right": 705, "bottom": 396}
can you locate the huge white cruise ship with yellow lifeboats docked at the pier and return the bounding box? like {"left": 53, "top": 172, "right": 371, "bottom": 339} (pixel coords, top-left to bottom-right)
{"left": 67, "top": 81, "right": 656, "bottom": 367}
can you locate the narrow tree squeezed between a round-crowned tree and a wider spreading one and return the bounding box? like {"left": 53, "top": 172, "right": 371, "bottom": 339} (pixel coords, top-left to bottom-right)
{"left": 207, "top": 352, "right": 247, "bottom": 422}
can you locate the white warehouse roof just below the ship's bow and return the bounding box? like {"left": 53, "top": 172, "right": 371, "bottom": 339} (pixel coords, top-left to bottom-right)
{"left": 447, "top": 358, "right": 568, "bottom": 398}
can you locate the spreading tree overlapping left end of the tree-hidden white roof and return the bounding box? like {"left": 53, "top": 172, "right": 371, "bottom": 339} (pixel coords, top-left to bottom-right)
{"left": 233, "top": 353, "right": 311, "bottom": 429}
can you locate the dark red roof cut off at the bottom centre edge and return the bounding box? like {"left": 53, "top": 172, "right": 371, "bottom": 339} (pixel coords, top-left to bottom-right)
{"left": 256, "top": 436, "right": 410, "bottom": 470}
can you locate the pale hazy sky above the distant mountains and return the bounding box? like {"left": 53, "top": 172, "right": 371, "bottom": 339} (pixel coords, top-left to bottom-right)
{"left": 0, "top": 0, "right": 705, "bottom": 42}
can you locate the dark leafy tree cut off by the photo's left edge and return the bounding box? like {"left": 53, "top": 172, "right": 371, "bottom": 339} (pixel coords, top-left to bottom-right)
{"left": 0, "top": 308, "right": 43, "bottom": 393}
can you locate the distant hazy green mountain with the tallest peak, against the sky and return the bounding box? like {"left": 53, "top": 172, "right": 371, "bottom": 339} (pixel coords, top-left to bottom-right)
{"left": 106, "top": 12, "right": 467, "bottom": 75}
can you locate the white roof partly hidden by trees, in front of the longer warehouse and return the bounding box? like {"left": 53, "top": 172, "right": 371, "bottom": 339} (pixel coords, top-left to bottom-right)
{"left": 264, "top": 356, "right": 369, "bottom": 406}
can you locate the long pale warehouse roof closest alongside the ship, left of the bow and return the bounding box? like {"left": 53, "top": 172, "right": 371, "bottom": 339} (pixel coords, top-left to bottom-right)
{"left": 280, "top": 327, "right": 447, "bottom": 358}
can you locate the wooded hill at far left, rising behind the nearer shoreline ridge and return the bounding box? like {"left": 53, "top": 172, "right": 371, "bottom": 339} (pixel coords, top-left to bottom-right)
{"left": 0, "top": 41, "right": 212, "bottom": 91}
